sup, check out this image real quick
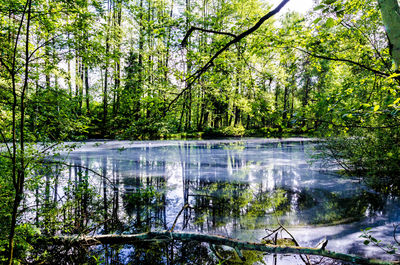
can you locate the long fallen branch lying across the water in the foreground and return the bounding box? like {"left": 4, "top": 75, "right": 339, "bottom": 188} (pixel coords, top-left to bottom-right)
{"left": 50, "top": 231, "right": 400, "bottom": 265}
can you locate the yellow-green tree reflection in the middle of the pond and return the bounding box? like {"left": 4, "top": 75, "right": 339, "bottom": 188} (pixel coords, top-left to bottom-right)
{"left": 191, "top": 181, "right": 286, "bottom": 231}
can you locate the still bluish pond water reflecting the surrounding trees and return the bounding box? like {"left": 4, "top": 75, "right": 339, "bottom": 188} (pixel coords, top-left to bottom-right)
{"left": 54, "top": 138, "right": 400, "bottom": 264}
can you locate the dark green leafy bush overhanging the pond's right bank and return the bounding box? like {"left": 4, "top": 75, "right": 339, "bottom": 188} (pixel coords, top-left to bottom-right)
{"left": 321, "top": 128, "right": 400, "bottom": 193}
